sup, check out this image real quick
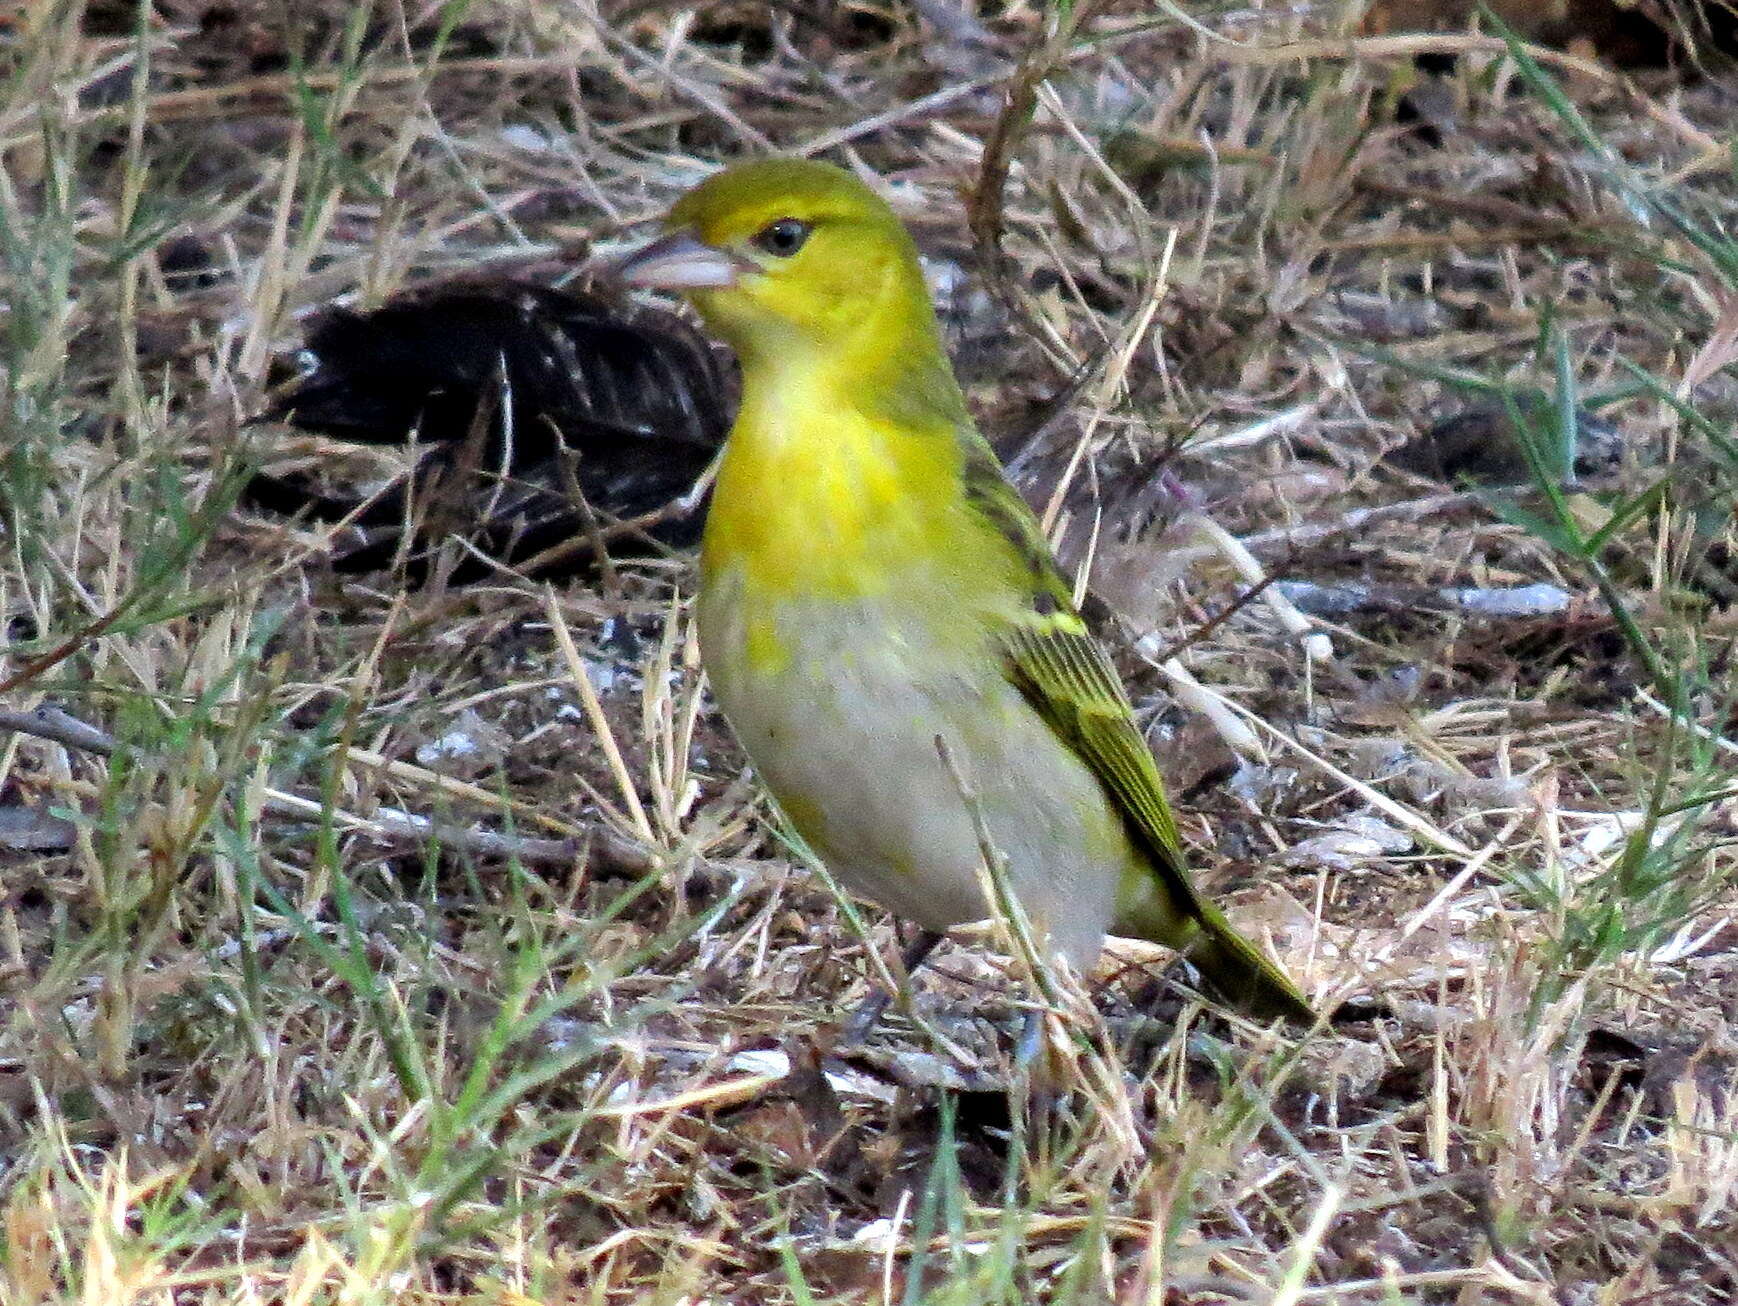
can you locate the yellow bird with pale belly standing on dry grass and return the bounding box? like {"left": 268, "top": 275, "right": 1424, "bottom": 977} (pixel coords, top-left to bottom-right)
{"left": 620, "top": 158, "right": 1314, "bottom": 1023}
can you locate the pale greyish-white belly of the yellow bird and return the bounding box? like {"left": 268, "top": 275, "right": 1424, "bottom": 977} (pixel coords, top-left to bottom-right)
{"left": 700, "top": 581, "right": 1137, "bottom": 969}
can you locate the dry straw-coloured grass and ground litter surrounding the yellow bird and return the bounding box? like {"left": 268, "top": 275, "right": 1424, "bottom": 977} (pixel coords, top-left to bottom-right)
{"left": 0, "top": 0, "right": 1738, "bottom": 1304}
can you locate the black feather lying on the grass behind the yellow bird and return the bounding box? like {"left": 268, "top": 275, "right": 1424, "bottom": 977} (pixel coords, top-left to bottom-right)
{"left": 245, "top": 282, "right": 733, "bottom": 579}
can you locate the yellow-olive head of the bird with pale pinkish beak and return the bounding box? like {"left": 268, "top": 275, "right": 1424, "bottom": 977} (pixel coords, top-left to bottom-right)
{"left": 620, "top": 158, "right": 937, "bottom": 375}
